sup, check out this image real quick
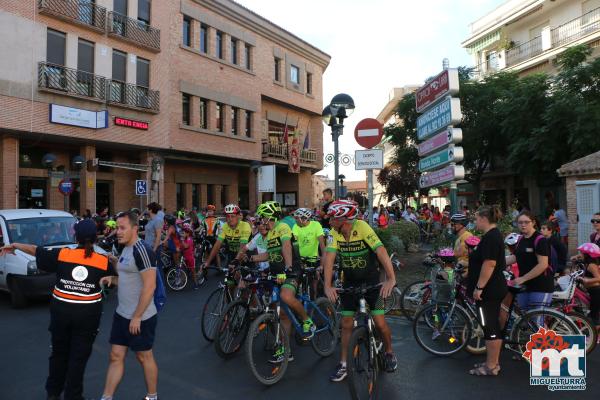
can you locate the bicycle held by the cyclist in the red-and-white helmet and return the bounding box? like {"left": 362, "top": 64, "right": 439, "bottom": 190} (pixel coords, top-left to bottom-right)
{"left": 337, "top": 283, "right": 384, "bottom": 399}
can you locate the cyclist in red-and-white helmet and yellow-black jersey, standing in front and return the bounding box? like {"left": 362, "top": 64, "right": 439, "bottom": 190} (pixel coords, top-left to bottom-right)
{"left": 324, "top": 200, "right": 398, "bottom": 382}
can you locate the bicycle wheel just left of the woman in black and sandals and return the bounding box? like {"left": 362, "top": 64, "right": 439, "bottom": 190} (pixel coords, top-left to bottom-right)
{"left": 413, "top": 303, "right": 473, "bottom": 356}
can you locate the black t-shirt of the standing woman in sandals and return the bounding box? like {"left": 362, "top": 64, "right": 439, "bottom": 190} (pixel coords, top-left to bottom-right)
{"left": 467, "top": 228, "right": 508, "bottom": 300}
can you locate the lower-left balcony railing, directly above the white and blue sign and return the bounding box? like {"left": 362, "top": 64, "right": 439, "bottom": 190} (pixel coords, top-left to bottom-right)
{"left": 38, "top": 62, "right": 106, "bottom": 102}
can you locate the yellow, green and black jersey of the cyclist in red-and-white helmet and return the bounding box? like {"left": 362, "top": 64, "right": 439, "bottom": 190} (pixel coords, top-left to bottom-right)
{"left": 327, "top": 220, "right": 383, "bottom": 284}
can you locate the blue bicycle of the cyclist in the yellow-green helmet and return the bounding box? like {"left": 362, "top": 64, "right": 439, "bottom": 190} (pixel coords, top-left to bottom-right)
{"left": 246, "top": 274, "right": 338, "bottom": 386}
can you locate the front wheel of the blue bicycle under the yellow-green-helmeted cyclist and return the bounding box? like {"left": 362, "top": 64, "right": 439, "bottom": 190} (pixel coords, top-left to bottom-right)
{"left": 246, "top": 313, "right": 290, "bottom": 386}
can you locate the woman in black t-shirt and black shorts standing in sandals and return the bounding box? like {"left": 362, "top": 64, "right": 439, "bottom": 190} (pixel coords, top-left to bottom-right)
{"left": 467, "top": 206, "right": 508, "bottom": 376}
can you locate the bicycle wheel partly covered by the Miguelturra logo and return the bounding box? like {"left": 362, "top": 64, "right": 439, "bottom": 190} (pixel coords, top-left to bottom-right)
{"left": 510, "top": 308, "right": 580, "bottom": 354}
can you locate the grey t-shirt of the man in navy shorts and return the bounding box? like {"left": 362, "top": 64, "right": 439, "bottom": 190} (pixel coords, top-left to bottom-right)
{"left": 116, "top": 240, "right": 156, "bottom": 321}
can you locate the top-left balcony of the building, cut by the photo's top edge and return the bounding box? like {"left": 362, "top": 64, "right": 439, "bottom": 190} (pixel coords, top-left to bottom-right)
{"left": 38, "top": 0, "right": 106, "bottom": 33}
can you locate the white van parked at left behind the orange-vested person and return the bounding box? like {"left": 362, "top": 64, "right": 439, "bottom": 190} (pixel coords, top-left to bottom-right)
{"left": 0, "top": 209, "right": 86, "bottom": 308}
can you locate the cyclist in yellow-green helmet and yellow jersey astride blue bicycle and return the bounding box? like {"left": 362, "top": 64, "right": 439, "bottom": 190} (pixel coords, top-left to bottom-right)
{"left": 250, "top": 201, "right": 315, "bottom": 364}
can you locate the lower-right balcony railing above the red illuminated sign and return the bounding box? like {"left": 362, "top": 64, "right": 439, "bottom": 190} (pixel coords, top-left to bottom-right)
{"left": 106, "top": 79, "right": 160, "bottom": 113}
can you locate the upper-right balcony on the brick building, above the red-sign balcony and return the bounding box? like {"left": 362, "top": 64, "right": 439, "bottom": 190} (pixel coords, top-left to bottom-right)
{"left": 108, "top": 11, "right": 160, "bottom": 52}
